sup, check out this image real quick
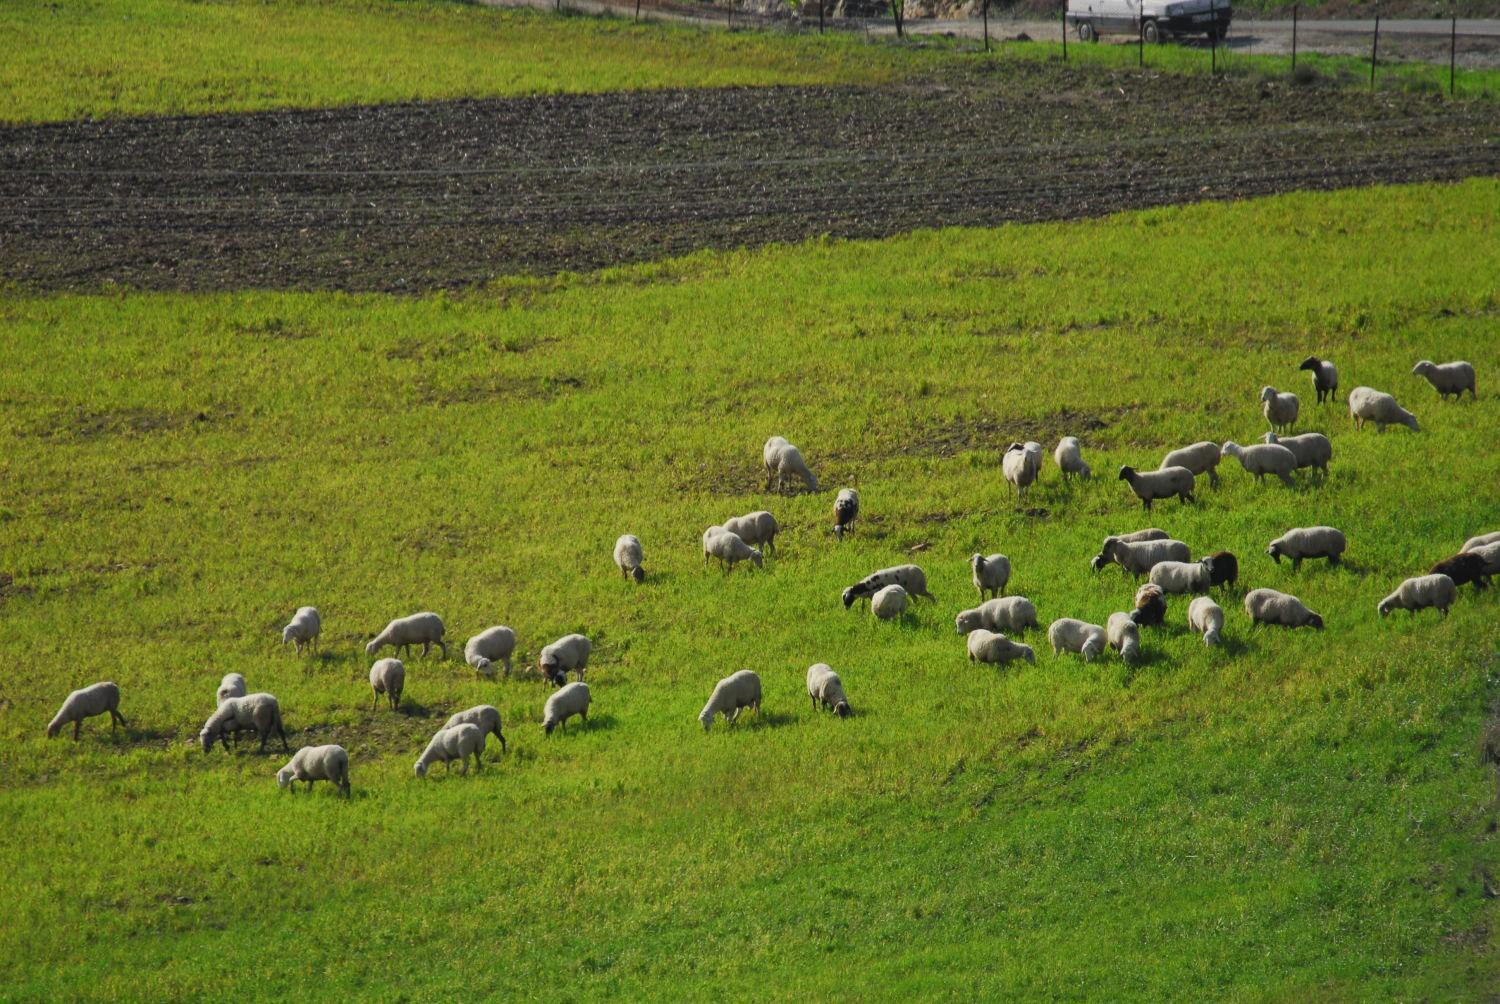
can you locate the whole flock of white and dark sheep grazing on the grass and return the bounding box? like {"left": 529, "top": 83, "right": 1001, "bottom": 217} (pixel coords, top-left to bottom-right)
{"left": 47, "top": 356, "right": 1500, "bottom": 795}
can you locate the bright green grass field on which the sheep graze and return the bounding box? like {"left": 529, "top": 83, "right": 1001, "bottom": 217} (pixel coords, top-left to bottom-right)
{"left": 0, "top": 182, "right": 1500, "bottom": 999}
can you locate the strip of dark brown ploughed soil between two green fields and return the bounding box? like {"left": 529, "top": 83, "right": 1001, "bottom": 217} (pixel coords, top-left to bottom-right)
{"left": 0, "top": 62, "right": 1500, "bottom": 291}
